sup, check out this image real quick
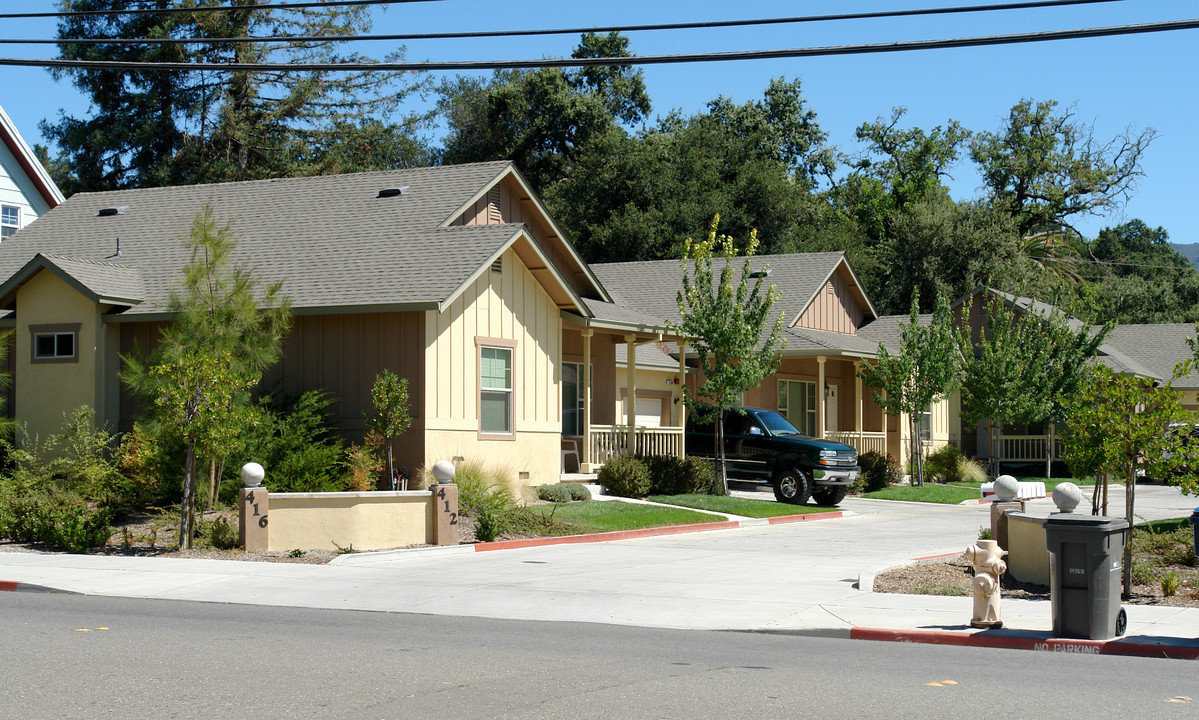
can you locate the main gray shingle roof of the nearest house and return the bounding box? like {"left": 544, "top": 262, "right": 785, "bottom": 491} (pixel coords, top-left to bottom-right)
{"left": 0, "top": 162, "right": 520, "bottom": 314}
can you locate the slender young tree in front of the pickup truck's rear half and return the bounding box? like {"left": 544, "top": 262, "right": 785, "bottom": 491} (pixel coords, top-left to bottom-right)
{"left": 674, "top": 216, "right": 787, "bottom": 495}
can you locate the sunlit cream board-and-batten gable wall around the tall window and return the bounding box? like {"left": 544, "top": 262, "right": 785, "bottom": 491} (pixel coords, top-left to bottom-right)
{"left": 424, "top": 244, "right": 562, "bottom": 485}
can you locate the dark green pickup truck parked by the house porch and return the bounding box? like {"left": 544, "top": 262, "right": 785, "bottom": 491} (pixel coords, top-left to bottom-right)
{"left": 686, "top": 407, "right": 860, "bottom": 506}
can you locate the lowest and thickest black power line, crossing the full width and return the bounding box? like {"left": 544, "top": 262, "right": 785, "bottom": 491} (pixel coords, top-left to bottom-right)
{"left": 0, "top": 19, "right": 1199, "bottom": 72}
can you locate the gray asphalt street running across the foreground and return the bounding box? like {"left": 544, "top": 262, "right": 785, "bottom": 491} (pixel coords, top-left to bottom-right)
{"left": 0, "top": 593, "right": 1199, "bottom": 720}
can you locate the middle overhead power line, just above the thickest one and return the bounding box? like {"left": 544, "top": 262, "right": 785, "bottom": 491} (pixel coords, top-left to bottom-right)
{"left": 0, "top": 0, "right": 1125, "bottom": 46}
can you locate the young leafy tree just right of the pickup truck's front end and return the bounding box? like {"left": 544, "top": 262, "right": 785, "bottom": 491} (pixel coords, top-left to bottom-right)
{"left": 858, "top": 288, "right": 960, "bottom": 486}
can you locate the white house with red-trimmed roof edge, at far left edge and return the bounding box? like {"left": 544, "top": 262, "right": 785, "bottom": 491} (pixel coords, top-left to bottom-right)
{"left": 0, "top": 108, "right": 62, "bottom": 241}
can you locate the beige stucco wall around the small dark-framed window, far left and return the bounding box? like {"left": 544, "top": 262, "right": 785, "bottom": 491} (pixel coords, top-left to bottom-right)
{"left": 13, "top": 271, "right": 109, "bottom": 440}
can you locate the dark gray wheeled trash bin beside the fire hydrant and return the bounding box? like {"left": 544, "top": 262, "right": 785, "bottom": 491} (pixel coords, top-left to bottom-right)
{"left": 1046, "top": 513, "right": 1128, "bottom": 640}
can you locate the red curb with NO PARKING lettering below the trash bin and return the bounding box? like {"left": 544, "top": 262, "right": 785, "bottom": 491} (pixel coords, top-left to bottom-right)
{"left": 849, "top": 628, "right": 1199, "bottom": 660}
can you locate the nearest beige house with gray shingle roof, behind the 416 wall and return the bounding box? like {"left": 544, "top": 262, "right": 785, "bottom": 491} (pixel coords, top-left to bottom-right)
{"left": 0, "top": 162, "right": 681, "bottom": 483}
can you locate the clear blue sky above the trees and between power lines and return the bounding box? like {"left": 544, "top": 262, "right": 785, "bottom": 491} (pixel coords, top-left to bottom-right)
{"left": 0, "top": 0, "right": 1199, "bottom": 243}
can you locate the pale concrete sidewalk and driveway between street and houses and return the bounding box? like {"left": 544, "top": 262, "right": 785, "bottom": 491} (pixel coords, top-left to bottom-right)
{"left": 0, "top": 488, "right": 1199, "bottom": 658}
